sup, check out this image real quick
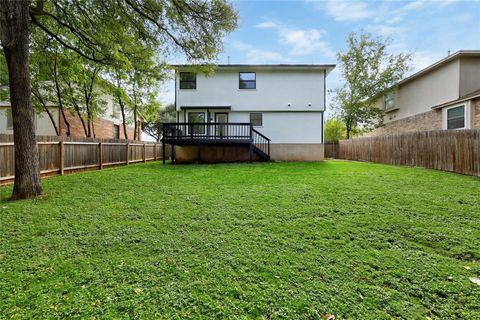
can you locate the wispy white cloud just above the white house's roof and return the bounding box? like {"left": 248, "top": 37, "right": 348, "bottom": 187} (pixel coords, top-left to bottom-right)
{"left": 256, "top": 21, "right": 335, "bottom": 57}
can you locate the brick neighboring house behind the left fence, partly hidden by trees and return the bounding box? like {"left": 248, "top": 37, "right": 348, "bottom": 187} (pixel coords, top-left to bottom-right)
{"left": 0, "top": 91, "right": 141, "bottom": 139}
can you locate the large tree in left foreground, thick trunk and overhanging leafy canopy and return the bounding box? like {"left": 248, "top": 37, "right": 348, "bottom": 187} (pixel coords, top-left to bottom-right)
{"left": 0, "top": 0, "right": 237, "bottom": 199}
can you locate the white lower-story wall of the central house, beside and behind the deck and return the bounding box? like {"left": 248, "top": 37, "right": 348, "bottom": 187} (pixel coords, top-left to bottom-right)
{"left": 179, "top": 109, "right": 322, "bottom": 144}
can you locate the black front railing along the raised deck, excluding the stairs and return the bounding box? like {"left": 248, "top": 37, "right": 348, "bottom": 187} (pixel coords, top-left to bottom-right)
{"left": 163, "top": 122, "right": 252, "bottom": 140}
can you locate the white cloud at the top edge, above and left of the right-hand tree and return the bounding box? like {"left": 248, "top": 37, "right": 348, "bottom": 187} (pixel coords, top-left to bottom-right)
{"left": 325, "top": 0, "right": 374, "bottom": 21}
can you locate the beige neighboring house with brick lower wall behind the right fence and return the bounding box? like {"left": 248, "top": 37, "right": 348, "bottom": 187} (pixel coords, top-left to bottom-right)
{"left": 366, "top": 50, "right": 480, "bottom": 136}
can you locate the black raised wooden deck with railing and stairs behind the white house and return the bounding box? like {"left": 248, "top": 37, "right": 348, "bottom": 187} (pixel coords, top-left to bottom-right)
{"left": 162, "top": 122, "right": 270, "bottom": 163}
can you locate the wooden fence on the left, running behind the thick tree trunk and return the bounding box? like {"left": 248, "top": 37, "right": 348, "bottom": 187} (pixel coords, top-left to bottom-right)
{"left": 0, "top": 134, "right": 169, "bottom": 183}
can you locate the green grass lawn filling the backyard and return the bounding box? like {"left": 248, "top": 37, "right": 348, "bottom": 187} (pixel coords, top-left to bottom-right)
{"left": 0, "top": 161, "right": 480, "bottom": 319}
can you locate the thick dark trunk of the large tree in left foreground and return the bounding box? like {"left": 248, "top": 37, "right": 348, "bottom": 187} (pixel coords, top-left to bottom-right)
{"left": 0, "top": 0, "right": 42, "bottom": 199}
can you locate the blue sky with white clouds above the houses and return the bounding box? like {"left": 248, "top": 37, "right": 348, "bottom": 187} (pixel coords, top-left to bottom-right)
{"left": 161, "top": 0, "right": 480, "bottom": 110}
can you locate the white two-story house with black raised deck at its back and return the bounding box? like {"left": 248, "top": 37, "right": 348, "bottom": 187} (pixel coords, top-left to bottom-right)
{"left": 163, "top": 64, "right": 335, "bottom": 162}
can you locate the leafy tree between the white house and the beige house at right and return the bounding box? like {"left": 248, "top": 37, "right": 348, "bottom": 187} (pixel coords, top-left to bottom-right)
{"left": 335, "top": 33, "right": 411, "bottom": 139}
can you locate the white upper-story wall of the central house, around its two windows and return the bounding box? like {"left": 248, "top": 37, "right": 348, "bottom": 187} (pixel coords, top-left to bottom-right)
{"left": 176, "top": 67, "right": 325, "bottom": 111}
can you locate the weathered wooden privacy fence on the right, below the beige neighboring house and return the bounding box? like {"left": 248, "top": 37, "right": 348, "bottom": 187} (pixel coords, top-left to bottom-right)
{"left": 325, "top": 129, "right": 480, "bottom": 176}
